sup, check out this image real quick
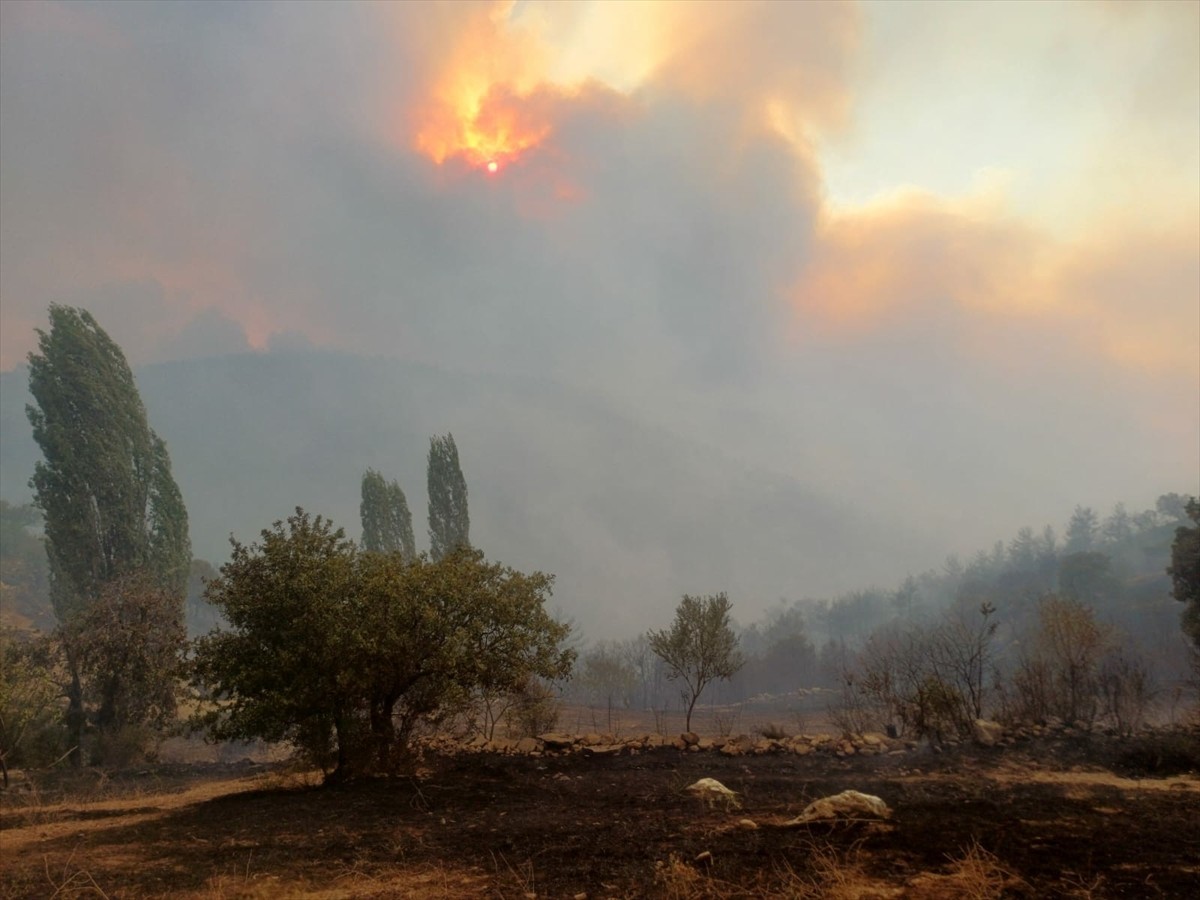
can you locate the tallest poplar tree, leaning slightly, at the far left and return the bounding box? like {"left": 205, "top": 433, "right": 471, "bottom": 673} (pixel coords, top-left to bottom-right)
{"left": 26, "top": 305, "right": 191, "bottom": 763}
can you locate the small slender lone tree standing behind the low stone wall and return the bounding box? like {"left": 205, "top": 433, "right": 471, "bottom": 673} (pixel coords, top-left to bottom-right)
{"left": 646, "top": 593, "right": 743, "bottom": 731}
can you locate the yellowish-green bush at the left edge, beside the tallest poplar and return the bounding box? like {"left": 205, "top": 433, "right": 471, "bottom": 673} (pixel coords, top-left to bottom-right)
{"left": 0, "top": 629, "right": 64, "bottom": 787}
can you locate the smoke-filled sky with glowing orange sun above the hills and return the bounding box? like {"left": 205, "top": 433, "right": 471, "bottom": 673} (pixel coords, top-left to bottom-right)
{"left": 0, "top": 0, "right": 1200, "bottom": 633}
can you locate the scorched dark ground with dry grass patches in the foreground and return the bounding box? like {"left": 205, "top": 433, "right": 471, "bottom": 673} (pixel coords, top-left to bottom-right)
{"left": 0, "top": 739, "right": 1200, "bottom": 898}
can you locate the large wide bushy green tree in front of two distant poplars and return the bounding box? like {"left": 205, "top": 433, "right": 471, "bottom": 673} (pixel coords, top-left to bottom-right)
{"left": 196, "top": 509, "right": 572, "bottom": 778}
